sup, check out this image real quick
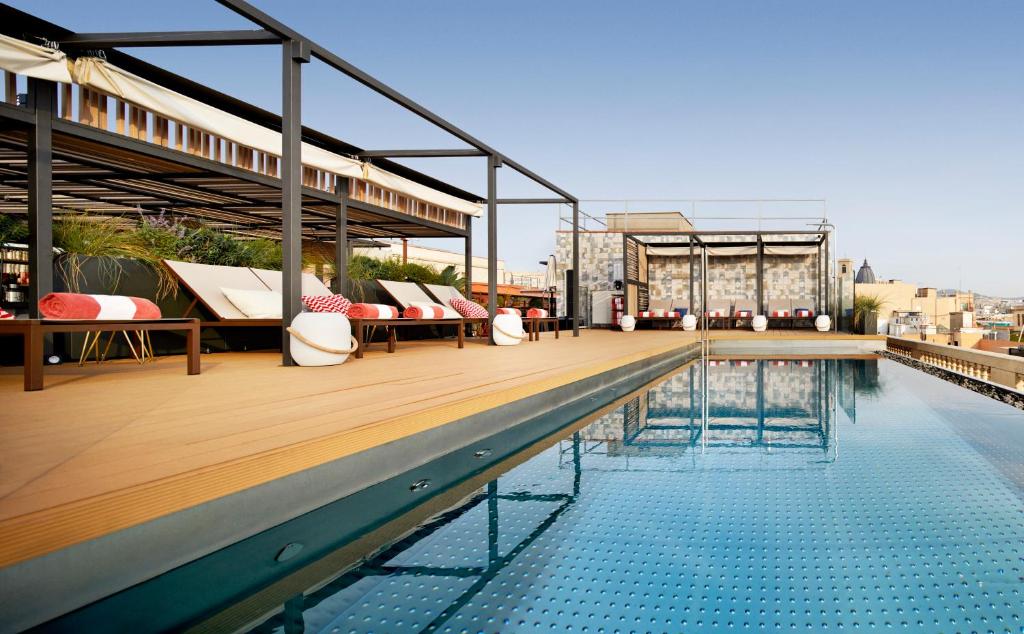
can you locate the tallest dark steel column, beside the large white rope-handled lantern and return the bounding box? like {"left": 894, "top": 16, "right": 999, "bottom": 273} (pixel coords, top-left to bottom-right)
{"left": 281, "top": 41, "right": 309, "bottom": 366}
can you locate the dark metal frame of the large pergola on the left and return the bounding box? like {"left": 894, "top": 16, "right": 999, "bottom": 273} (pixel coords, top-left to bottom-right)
{"left": 0, "top": 0, "right": 580, "bottom": 366}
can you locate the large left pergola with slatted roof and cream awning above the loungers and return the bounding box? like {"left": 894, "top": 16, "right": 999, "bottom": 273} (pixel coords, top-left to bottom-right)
{"left": 0, "top": 0, "right": 579, "bottom": 365}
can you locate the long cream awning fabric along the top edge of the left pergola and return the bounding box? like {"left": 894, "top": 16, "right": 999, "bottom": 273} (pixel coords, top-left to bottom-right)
{"left": 0, "top": 35, "right": 482, "bottom": 216}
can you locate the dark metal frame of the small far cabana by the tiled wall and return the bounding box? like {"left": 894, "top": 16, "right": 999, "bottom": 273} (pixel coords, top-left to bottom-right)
{"left": 623, "top": 229, "right": 838, "bottom": 324}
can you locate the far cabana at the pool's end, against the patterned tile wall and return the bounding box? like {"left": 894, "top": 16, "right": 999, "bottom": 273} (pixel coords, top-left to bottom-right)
{"left": 623, "top": 229, "right": 833, "bottom": 325}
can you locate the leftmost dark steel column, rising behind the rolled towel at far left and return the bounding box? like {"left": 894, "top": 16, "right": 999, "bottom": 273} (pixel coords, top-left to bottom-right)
{"left": 25, "top": 78, "right": 57, "bottom": 317}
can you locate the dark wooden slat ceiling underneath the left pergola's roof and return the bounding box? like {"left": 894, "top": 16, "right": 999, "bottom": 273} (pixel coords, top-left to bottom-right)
{"left": 0, "top": 129, "right": 458, "bottom": 242}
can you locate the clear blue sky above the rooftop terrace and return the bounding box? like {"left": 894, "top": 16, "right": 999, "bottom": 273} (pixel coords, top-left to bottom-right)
{"left": 16, "top": 0, "right": 1024, "bottom": 295}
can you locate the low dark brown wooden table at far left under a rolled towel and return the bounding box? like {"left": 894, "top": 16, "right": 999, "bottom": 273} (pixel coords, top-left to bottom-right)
{"left": 0, "top": 319, "right": 200, "bottom": 391}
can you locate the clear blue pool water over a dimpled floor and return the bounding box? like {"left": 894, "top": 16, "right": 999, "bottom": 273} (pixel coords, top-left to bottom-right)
{"left": 247, "top": 360, "right": 1024, "bottom": 633}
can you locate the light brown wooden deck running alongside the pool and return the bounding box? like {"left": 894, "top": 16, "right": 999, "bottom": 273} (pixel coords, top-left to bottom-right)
{"left": 0, "top": 330, "right": 880, "bottom": 566}
